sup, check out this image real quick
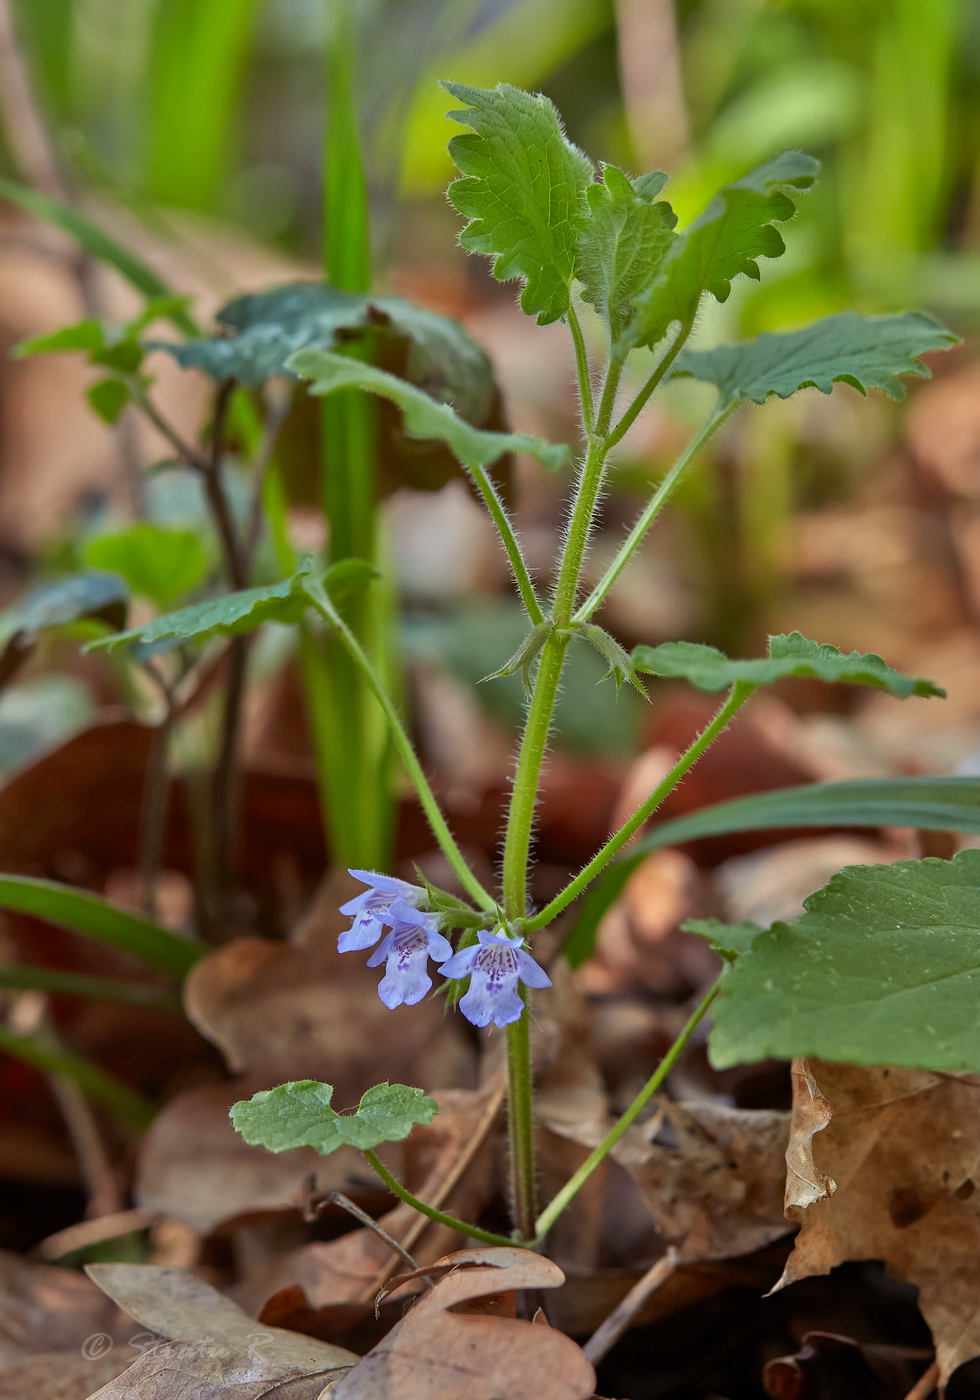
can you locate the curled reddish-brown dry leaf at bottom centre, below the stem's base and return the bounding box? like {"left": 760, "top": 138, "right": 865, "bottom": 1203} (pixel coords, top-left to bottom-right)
{"left": 330, "top": 1249, "right": 595, "bottom": 1400}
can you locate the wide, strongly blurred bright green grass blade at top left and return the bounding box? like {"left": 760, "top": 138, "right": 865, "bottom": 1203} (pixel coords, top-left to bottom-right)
{"left": 141, "top": 0, "right": 259, "bottom": 211}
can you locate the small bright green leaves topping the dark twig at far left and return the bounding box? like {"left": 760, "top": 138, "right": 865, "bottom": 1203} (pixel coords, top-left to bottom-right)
{"left": 14, "top": 295, "right": 190, "bottom": 423}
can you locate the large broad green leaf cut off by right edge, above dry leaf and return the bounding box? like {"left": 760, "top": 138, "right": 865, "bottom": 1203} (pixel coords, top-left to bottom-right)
{"left": 708, "top": 850, "right": 980, "bottom": 1072}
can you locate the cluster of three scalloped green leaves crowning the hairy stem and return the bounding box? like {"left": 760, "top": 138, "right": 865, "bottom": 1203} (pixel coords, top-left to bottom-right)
{"left": 445, "top": 83, "right": 819, "bottom": 349}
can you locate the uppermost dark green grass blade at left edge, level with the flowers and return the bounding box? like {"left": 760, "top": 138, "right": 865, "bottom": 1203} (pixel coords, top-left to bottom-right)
{"left": 0, "top": 875, "right": 204, "bottom": 977}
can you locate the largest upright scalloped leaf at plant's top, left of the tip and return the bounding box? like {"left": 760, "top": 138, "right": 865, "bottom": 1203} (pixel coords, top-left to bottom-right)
{"left": 442, "top": 83, "right": 592, "bottom": 325}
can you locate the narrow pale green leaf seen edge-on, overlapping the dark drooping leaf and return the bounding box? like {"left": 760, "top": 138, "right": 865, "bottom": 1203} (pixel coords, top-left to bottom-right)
{"left": 290, "top": 350, "right": 568, "bottom": 469}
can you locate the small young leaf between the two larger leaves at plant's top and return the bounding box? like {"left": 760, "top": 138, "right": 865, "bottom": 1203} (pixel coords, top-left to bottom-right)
{"left": 575, "top": 165, "right": 678, "bottom": 336}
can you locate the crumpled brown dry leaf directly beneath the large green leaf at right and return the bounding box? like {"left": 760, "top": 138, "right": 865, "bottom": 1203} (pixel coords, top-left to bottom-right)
{"left": 777, "top": 1061, "right": 980, "bottom": 1383}
